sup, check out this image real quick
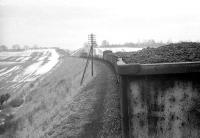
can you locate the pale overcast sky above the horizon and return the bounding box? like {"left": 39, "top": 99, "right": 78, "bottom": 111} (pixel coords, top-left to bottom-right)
{"left": 0, "top": 0, "right": 200, "bottom": 49}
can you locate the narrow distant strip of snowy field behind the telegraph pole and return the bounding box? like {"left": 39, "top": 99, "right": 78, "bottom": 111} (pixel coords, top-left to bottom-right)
{"left": 94, "top": 47, "right": 142, "bottom": 56}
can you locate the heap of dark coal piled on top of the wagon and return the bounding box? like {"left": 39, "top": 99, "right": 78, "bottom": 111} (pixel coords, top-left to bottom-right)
{"left": 116, "top": 42, "right": 200, "bottom": 64}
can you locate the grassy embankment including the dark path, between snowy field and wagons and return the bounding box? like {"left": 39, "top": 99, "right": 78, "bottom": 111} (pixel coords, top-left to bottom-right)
{"left": 2, "top": 57, "right": 120, "bottom": 138}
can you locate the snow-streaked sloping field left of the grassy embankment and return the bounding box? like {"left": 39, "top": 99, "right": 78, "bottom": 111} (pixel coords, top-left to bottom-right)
{"left": 0, "top": 49, "right": 59, "bottom": 92}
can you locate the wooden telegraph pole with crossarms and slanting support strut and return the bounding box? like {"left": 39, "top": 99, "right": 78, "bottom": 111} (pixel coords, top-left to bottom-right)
{"left": 80, "top": 34, "right": 96, "bottom": 84}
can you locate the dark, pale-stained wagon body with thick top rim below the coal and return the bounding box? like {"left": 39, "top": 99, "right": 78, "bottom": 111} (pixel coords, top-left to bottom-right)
{"left": 117, "top": 62, "right": 200, "bottom": 138}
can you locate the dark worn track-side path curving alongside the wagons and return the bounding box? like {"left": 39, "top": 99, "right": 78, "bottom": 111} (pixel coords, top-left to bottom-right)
{"left": 79, "top": 62, "right": 121, "bottom": 138}
